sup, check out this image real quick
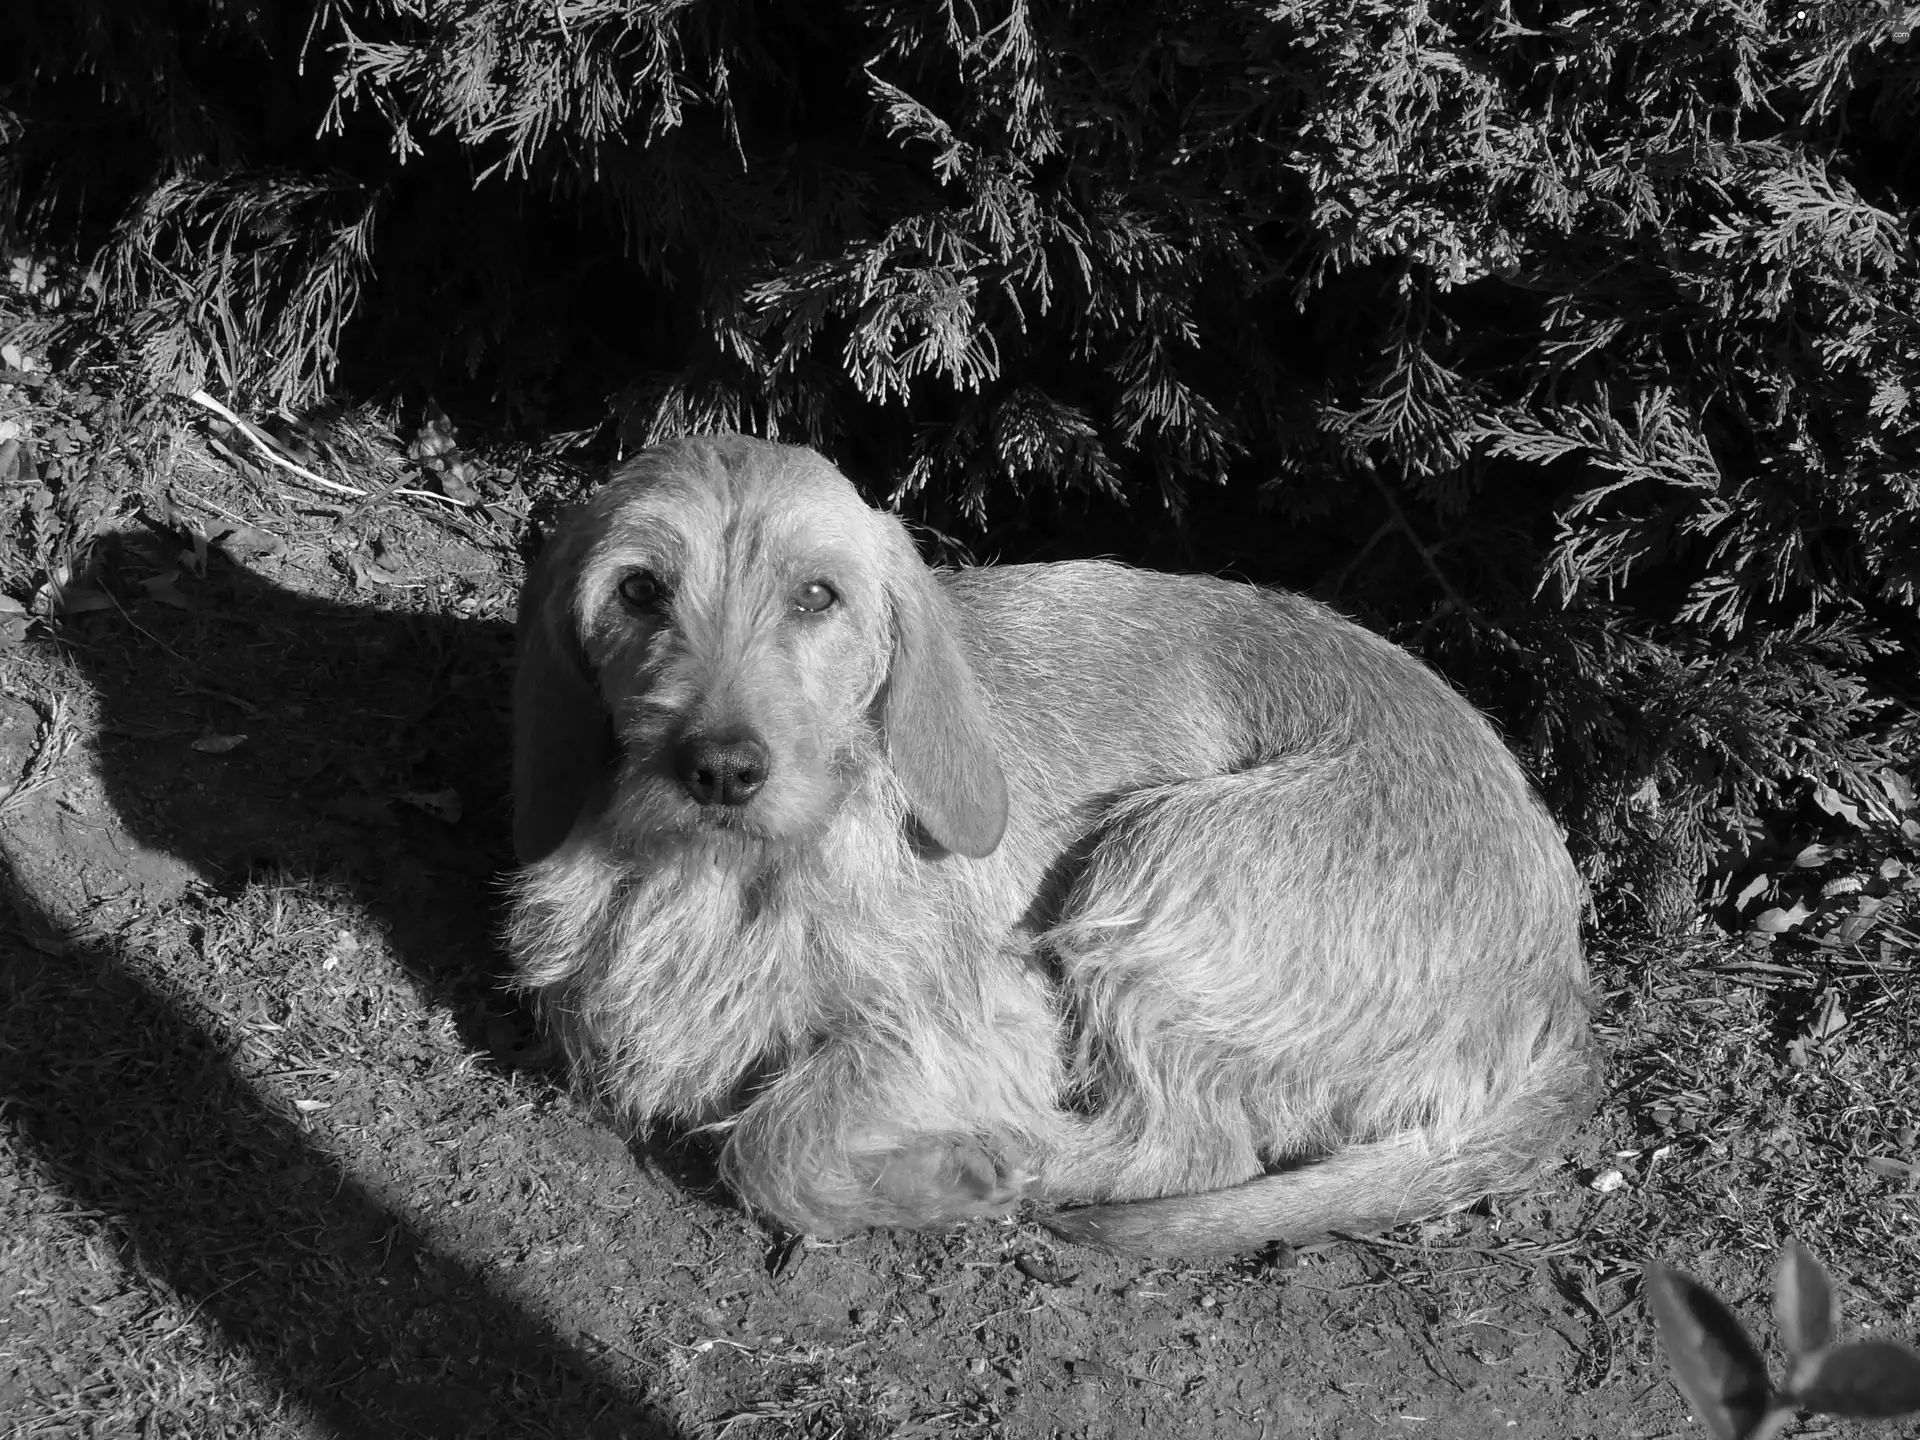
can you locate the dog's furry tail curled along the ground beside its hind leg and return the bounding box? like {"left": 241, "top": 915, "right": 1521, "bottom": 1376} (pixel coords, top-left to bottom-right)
{"left": 1043, "top": 1048, "right": 1599, "bottom": 1256}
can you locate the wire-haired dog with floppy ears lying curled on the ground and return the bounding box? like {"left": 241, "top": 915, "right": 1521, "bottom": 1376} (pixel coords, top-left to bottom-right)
{"left": 511, "top": 436, "right": 1594, "bottom": 1254}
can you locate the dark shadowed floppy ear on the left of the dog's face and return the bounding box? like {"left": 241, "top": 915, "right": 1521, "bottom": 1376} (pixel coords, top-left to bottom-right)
{"left": 513, "top": 541, "right": 612, "bottom": 864}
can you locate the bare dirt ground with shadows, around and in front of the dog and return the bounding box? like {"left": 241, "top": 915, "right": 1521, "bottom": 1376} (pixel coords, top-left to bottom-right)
{"left": 0, "top": 428, "right": 1920, "bottom": 1440}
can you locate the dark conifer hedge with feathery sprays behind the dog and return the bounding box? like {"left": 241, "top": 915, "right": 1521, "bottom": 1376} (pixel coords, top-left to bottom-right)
{"left": 0, "top": 0, "right": 1920, "bottom": 925}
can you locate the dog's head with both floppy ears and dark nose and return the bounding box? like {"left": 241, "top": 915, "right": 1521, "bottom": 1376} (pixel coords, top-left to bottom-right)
{"left": 513, "top": 436, "right": 1006, "bottom": 862}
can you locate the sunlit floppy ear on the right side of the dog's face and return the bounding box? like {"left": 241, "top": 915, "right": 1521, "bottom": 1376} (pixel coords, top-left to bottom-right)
{"left": 881, "top": 524, "right": 1006, "bottom": 858}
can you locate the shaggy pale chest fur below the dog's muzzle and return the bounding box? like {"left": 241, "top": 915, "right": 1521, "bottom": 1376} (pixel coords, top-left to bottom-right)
{"left": 509, "top": 725, "right": 906, "bottom": 1125}
